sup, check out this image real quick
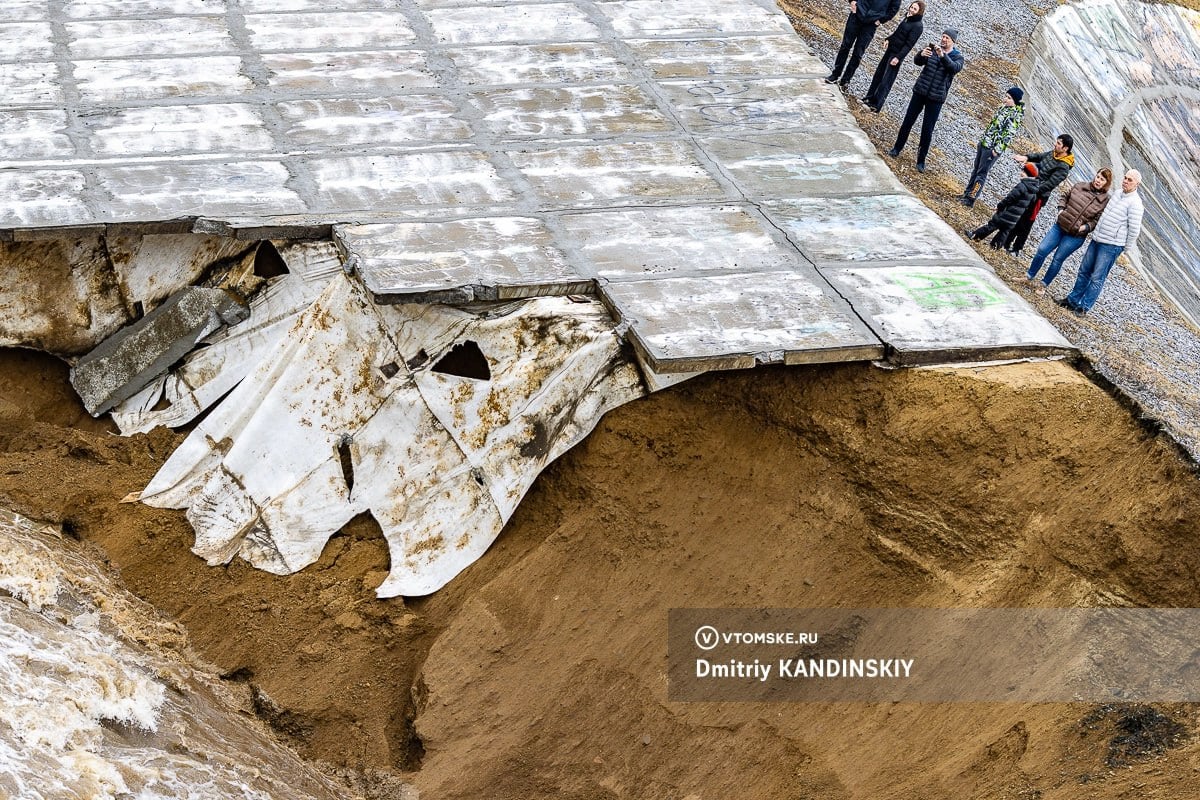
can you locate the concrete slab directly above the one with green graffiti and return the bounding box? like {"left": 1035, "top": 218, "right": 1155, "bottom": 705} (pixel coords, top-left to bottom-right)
{"left": 763, "top": 194, "right": 979, "bottom": 266}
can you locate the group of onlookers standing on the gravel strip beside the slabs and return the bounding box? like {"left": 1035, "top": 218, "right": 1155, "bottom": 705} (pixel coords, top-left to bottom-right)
{"left": 826, "top": 0, "right": 1144, "bottom": 314}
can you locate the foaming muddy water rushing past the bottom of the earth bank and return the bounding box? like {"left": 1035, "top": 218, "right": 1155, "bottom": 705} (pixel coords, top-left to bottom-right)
{"left": 0, "top": 510, "right": 341, "bottom": 800}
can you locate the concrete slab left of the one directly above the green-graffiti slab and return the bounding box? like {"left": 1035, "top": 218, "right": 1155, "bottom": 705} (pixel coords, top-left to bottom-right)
{"left": 558, "top": 205, "right": 803, "bottom": 282}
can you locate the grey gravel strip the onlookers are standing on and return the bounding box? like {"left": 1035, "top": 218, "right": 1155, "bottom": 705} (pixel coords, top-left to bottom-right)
{"left": 780, "top": 0, "right": 1200, "bottom": 461}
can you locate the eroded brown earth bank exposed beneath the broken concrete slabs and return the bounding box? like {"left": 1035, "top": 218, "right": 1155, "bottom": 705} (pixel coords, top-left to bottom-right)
{"left": 0, "top": 355, "right": 1200, "bottom": 799}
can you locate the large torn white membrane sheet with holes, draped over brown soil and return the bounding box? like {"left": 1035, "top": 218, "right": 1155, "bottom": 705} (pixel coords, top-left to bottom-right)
{"left": 142, "top": 276, "right": 643, "bottom": 597}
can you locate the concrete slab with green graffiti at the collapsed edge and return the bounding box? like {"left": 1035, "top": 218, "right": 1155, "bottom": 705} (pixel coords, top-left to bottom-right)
{"left": 821, "top": 266, "right": 1074, "bottom": 365}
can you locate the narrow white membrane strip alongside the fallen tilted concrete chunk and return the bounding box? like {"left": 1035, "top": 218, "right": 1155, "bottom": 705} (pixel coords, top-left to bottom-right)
{"left": 112, "top": 243, "right": 342, "bottom": 435}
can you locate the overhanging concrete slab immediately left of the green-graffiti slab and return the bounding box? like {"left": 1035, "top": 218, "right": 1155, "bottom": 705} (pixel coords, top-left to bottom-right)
{"left": 600, "top": 271, "right": 884, "bottom": 373}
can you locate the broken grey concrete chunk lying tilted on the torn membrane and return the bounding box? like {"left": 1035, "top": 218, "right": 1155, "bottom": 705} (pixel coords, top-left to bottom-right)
{"left": 71, "top": 287, "right": 250, "bottom": 416}
